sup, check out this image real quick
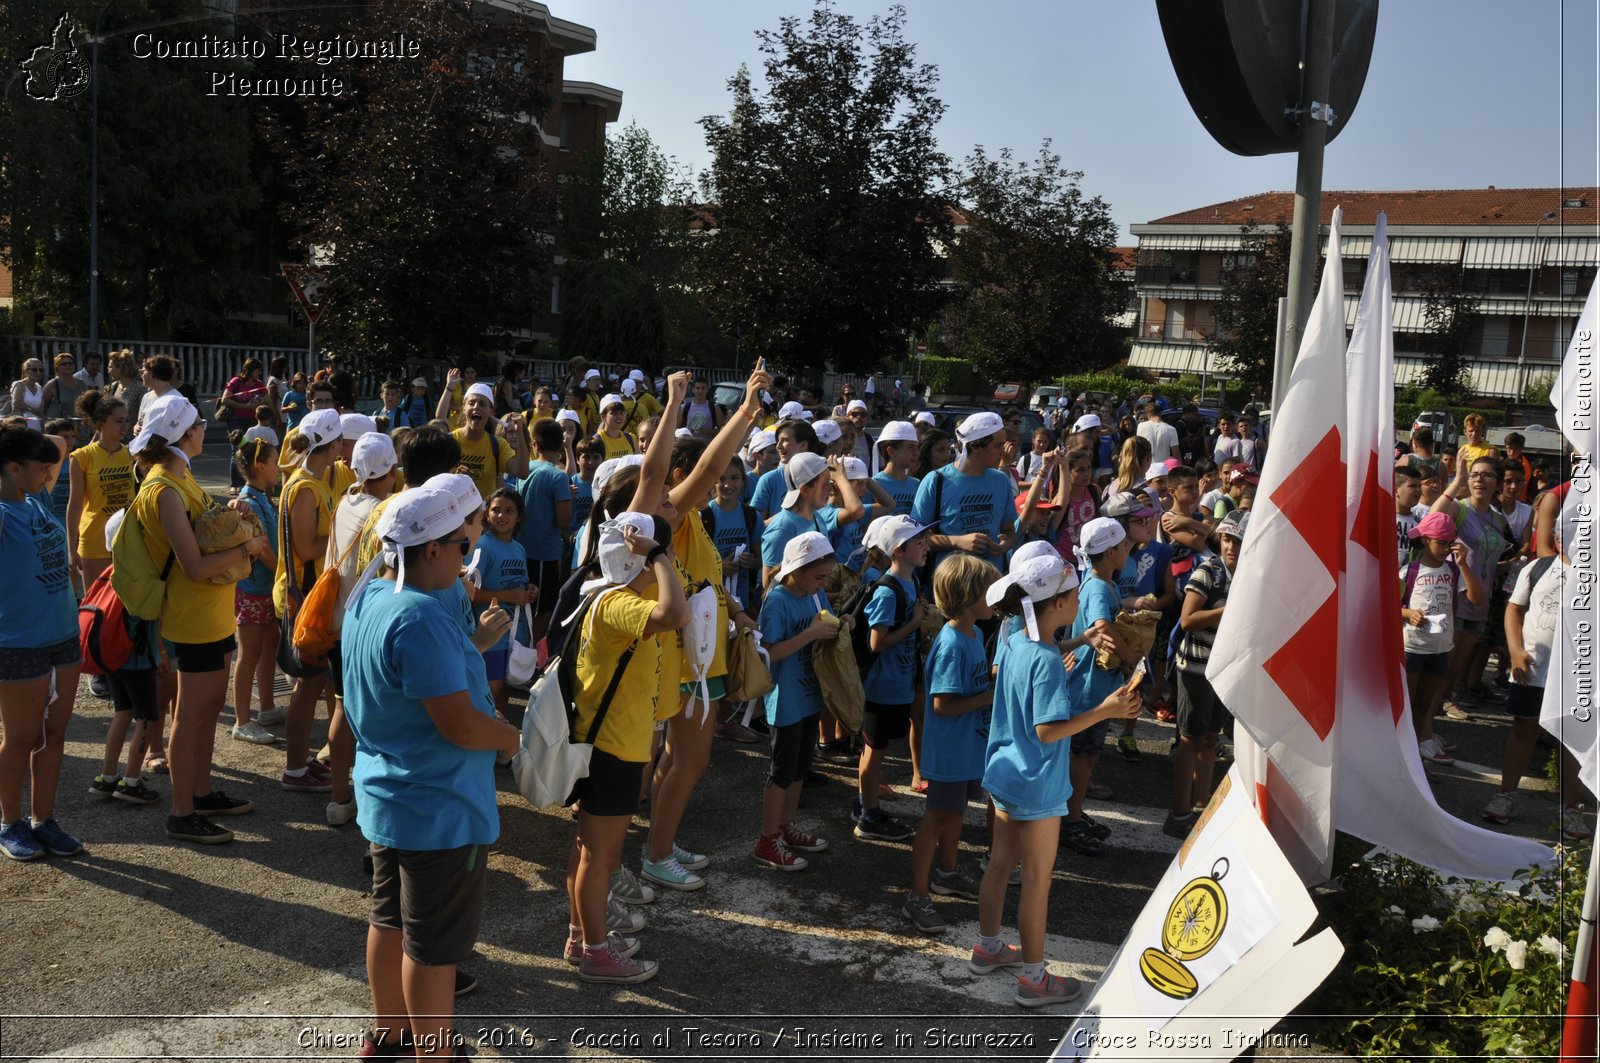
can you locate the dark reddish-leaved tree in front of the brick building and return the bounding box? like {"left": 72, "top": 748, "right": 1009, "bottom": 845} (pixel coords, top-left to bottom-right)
{"left": 261, "top": 0, "right": 555, "bottom": 365}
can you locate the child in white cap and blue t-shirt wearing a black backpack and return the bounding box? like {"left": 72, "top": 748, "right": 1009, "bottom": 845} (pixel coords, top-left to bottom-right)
{"left": 853, "top": 515, "right": 928, "bottom": 840}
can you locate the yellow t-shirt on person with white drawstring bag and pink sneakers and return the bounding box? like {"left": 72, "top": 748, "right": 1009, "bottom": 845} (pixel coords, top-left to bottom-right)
{"left": 573, "top": 588, "right": 662, "bottom": 764}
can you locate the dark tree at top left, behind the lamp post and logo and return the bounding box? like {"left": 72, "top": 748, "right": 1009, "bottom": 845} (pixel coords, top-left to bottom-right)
{"left": 0, "top": 0, "right": 259, "bottom": 339}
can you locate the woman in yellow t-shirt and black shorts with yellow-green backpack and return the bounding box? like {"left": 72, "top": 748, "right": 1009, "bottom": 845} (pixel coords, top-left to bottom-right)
{"left": 128, "top": 392, "right": 267, "bottom": 845}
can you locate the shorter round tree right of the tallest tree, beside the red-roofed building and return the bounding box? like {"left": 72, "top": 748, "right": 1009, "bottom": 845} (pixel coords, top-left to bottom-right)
{"left": 947, "top": 139, "right": 1118, "bottom": 381}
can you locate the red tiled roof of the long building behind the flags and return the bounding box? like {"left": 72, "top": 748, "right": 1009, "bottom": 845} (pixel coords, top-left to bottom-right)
{"left": 1147, "top": 186, "right": 1600, "bottom": 226}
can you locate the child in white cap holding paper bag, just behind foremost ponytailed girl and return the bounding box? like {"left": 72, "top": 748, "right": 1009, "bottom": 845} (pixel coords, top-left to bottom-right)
{"left": 1064, "top": 517, "right": 1139, "bottom": 856}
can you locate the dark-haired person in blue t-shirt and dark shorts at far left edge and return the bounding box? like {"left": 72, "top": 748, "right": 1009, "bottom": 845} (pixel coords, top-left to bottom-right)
{"left": 0, "top": 427, "right": 83, "bottom": 860}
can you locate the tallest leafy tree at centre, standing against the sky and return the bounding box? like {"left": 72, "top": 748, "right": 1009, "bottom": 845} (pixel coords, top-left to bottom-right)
{"left": 694, "top": 0, "right": 954, "bottom": 382}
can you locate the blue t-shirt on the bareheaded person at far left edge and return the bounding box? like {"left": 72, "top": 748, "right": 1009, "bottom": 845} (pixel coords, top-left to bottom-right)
{"left": 0, "top": 495, "right": 78, "bottom": 650}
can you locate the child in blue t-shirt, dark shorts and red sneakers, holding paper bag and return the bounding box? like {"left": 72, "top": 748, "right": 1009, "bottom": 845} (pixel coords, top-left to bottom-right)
{"left": 755, "top": 532, "right": 848, "bottom": 871}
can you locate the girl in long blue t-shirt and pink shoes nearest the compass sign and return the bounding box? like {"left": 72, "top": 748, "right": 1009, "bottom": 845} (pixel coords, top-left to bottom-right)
{"left": 968, "top": 556, "right": 1139, "bottom": 1007}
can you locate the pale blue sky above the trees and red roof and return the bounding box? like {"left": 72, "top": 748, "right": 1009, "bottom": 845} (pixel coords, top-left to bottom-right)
{"left": 547, "top": 0, "right": 1600, "bottom": 245}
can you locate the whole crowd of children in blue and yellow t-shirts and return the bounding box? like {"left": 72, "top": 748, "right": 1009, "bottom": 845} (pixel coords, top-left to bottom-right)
{"left": 0, "top": 355, "right": 1587, "bottom": 1055}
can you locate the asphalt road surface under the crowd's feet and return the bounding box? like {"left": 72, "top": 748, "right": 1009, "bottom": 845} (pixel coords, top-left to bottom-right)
{"left": 0, "top": 435, "right": 1555, "bottom": 1060}
